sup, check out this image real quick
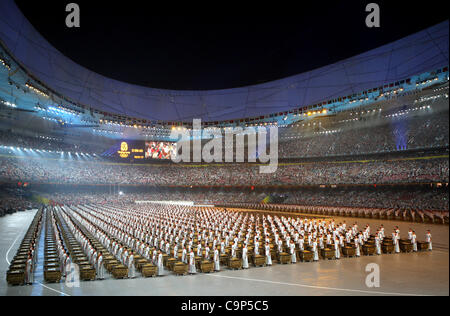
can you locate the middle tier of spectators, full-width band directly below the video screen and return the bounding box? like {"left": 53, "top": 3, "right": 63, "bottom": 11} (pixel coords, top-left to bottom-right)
{"left": 0, "top": 157, "right": 449, "bottom": 186}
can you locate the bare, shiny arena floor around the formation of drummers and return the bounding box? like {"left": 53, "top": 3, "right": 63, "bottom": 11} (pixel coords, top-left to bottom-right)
{"left": 0, "top": 211, "right": 449, "bottom": 296}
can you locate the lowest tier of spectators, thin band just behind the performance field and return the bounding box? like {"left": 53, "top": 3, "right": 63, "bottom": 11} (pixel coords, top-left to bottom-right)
{"left": 40, "top": 187, "right": 449, "bottom": 211}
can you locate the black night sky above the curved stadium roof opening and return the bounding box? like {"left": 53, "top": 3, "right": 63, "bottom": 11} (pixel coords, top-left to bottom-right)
{"left": 16, "top": 0, "right": 448, "bottom": 90}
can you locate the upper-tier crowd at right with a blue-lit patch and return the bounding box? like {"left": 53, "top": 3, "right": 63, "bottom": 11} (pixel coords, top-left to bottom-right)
{"left": 279, "top": 112, "right": 449, "bottom": 158}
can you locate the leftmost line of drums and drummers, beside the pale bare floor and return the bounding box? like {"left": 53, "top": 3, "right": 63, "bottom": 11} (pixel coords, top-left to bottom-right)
{"left": 6, "top": 208, "right": 44, "bottom": 285}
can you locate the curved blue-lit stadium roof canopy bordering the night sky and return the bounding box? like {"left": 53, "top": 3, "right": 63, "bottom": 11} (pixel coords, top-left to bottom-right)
{"left": 0, "top": 0, "right": 449, "bottom": 122}
